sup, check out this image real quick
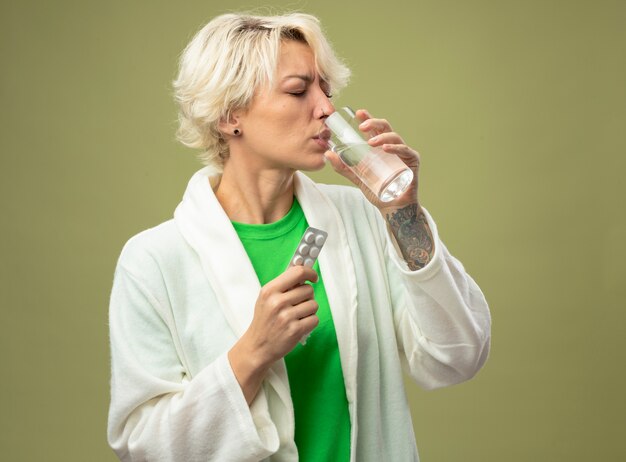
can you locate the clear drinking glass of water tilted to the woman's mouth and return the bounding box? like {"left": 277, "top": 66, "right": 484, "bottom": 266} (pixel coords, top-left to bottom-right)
{"left": 322, "top": 106, "right": 413, "bottom": 202}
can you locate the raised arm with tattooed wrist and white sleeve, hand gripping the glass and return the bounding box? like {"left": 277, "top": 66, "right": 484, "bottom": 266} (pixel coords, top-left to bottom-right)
{"left": 327, "top": 110, "right": 491, "bottom": 389}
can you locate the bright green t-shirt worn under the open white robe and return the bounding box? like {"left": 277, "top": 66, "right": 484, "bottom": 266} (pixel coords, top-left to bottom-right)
{"left": 233, "top": 198, "right": 350, "bottom": 462}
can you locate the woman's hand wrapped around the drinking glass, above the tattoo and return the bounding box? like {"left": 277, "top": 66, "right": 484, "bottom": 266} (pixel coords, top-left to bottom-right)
{"left": 326, "top": 109, "right": 420, "bottom": 212}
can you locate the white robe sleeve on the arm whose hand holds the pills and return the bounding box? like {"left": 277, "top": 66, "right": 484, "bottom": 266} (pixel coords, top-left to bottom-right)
{"left": 108, "top": 244, "right": 279, "bottom": 462}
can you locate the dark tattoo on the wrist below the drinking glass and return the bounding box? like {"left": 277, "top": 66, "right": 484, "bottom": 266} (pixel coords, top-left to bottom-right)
{"left": 386, "top": 204, "right": 434, "bottom": 270}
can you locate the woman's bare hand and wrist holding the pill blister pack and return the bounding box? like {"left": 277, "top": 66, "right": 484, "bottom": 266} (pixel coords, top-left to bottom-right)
{"left": 228, "top": 266, "right": 319, "bottom": 404}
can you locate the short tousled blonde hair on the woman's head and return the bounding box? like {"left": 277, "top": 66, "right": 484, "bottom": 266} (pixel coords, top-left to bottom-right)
{"left": 174, "top": 13, "right": 350, "bottom": 171}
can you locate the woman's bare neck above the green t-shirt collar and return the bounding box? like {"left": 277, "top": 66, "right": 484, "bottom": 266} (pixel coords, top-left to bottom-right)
{"left": 215, "top": 157, "right": 294, "bottom": 224}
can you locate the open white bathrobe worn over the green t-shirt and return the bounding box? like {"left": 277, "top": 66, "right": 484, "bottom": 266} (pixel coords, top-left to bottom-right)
{"left": 108, "top": 167, "right": 490, "bottom": 462}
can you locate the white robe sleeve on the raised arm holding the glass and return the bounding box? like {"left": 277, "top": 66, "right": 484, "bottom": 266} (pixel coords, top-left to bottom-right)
{"left": 380, "top": 206, "right": 491, "bottom": 389}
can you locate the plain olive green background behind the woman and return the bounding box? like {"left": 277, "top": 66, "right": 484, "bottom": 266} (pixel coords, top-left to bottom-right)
{"left": 0, "top": 0, "right": 626, "bottom": 462}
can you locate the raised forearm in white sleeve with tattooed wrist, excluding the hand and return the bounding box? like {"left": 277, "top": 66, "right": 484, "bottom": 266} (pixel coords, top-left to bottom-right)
{"left": 384, "top": 204, "right": 490, "bottom": 389}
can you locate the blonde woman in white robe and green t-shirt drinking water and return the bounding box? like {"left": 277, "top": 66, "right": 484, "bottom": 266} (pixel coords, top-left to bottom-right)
{"left": 108, "top": 10, "right": 490, "bottom": 462}
